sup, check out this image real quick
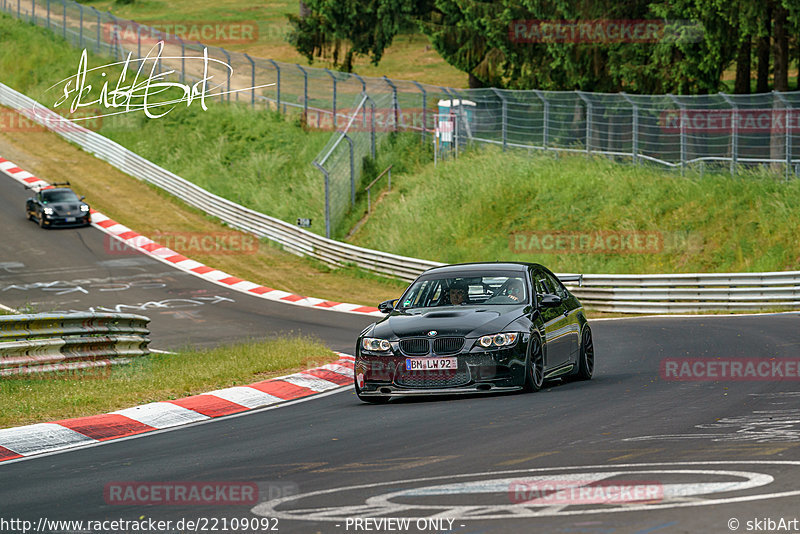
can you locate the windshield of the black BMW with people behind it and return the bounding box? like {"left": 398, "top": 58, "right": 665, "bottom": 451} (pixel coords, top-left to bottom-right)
{"left": 400, "top": 273, "right": 528, "bottom": 308}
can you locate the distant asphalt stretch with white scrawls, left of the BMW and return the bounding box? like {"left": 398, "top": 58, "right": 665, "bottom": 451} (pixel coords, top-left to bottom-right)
{"left": 0, "top": 175, "right": 374, "bottom": 353}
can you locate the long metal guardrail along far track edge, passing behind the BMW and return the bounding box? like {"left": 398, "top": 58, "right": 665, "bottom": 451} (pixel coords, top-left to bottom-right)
{"left": 0, "top": 83, "right": 800, "bottom": 313}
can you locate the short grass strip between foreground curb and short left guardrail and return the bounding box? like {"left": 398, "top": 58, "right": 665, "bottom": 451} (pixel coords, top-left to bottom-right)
{"left": 0, "top": 338, "right": 337, "bottom": 428}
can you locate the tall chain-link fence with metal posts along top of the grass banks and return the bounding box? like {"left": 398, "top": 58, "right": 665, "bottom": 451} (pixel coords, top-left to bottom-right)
{"left": 0, "top": 0, "right": 800, "bottom": 239}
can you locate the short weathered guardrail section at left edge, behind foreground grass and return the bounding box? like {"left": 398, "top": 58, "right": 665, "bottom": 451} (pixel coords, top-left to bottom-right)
{"left": 0, "top": 313, "right": 150, "bottom": 377}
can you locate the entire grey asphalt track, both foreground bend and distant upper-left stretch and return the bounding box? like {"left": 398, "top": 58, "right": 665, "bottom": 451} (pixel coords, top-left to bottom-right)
{"left": 0, "top": 173, "right": 800, "bottom": 534}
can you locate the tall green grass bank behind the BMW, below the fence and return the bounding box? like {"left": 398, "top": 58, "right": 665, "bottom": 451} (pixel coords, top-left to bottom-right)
{"left": 352, "top": 149, "right": 800, "bottom": 273}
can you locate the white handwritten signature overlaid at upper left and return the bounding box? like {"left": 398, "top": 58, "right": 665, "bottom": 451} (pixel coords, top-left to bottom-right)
{"left": 47, "top": 41, "right": 275, "bottom": 121}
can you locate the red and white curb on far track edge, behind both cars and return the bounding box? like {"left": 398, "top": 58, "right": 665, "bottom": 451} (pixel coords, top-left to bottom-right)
{"left": 0, "top": 157, "right": 383, "bottom": 317}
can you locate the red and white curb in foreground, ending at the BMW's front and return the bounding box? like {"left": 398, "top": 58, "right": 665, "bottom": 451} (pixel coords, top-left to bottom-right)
{"left": 0, "top": 353, "right": 354, "bottom": 462}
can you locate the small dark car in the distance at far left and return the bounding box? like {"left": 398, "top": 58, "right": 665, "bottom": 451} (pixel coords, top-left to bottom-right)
{"left": 25, "top": 184, "right": 92, "bottom": 228}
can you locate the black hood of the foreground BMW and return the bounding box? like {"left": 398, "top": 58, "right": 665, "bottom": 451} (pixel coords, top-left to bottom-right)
{"left": 371, "top": 304, "right": 525, "bottom": 339}
